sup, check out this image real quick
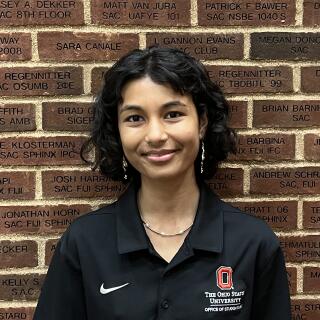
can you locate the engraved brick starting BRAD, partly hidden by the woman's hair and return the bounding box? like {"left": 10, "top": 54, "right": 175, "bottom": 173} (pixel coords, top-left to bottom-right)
{"left": 42, "top": 102, "right": 93, "bottom": 131}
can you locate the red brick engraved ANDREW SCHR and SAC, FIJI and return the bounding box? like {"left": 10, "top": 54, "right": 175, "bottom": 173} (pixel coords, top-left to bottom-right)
{"left": 250, "top": 167, "right": 320, "bottom": 195}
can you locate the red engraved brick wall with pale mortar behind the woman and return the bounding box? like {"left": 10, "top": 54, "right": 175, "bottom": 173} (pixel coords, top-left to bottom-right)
{"left": 0, "top": 0, "right": 320, "bottom": 320}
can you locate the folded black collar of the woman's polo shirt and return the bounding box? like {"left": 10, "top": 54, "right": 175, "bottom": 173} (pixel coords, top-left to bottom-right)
{"left": 115, "top": 182, "right": 223, "bottom": 254}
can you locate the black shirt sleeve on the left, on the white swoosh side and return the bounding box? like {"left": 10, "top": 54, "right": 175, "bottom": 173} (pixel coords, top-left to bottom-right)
{"left": 33, "top": 228, "right": 87, "bottom": 320}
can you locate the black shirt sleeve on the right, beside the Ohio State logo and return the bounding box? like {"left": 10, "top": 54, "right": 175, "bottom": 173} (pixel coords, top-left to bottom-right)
{"left": 251, "top": 247, "right": 291, "bottom": 320}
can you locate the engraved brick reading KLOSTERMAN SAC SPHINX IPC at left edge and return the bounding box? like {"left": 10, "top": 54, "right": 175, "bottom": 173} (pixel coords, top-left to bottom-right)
{"left": 0, "top": 136, "right": 87, "bottom": 165}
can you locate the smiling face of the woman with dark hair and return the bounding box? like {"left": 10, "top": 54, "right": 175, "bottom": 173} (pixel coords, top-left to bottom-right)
{"left": 118, "top": 77, "right": 207, "bottom": 179}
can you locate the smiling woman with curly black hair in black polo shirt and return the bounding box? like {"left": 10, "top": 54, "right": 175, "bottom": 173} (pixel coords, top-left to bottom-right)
{"left": 34, "top": 47, "right": 291, "bottom": 320}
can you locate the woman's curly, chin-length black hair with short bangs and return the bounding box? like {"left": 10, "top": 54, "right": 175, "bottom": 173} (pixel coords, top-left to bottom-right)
{"left": 80, "top": 45, "right": 236, "bottom": 183}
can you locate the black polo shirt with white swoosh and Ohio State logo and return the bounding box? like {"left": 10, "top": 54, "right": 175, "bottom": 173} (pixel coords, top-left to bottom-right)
{"left": 34, "top": 183, "right": 291, "bottom": 320}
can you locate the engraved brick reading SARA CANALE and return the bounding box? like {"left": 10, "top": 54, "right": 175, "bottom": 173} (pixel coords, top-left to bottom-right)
{"left": 38, "top": 31, "right": 139, "bottom": 61}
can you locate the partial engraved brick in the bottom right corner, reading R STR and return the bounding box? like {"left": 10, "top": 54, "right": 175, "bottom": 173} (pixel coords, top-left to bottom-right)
{"left": 291, "top": 299, "right": 320, "bottom": 320}
